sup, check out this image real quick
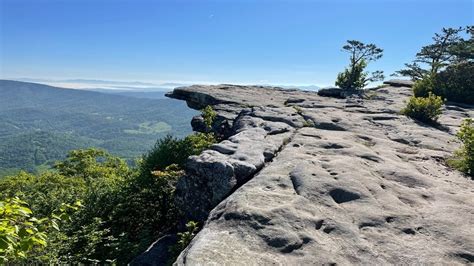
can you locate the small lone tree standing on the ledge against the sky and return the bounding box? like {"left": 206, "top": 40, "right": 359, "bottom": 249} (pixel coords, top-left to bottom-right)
{"left": 336, "top": 40, "right": 384, "bottom": 90}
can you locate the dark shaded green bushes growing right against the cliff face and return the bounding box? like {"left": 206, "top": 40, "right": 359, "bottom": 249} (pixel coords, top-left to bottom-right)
{"left": 66, "top": 133, "right": 215, "bottom": 264}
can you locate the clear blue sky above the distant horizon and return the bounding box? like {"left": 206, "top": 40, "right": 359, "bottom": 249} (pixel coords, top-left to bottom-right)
{"left": 0, "top": 0, "right": 474, "bottom": 85}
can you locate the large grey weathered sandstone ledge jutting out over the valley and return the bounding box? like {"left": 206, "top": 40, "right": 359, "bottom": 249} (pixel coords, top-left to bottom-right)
{"left": 169, "top": 82, "right": 474, "bottom": 265}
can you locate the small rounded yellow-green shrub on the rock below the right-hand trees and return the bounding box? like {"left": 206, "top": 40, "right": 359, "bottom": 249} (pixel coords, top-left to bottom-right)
{"left": 402, "top": 92, "right": 444, "bottom": 124}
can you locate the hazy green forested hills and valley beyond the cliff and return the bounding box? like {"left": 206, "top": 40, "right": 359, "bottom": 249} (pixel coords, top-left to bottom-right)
{"left": 0, "top": 80, "right": 196, "bottom": 175}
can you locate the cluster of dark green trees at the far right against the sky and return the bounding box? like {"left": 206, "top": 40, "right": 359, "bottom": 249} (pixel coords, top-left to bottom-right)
{"left": 396, "top": 26, "right": 474, "bottom": 104}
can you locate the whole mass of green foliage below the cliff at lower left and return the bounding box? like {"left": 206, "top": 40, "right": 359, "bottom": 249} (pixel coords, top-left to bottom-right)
{"left": 0, "top": 129, "right": 215, "bottom": 264}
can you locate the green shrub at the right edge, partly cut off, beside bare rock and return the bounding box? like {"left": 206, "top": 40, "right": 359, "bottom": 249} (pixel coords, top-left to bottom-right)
{"left": 448, "top": 119, "right": 474, "bottom": 177}
